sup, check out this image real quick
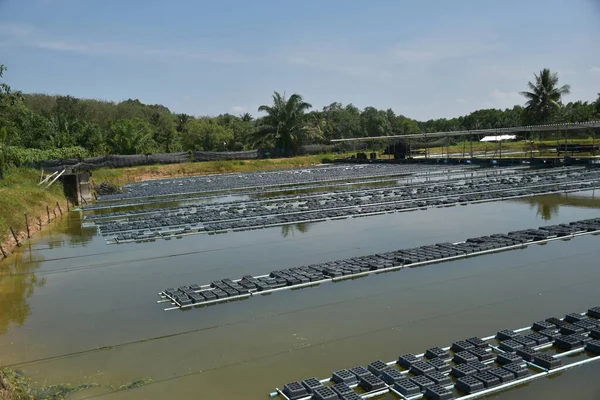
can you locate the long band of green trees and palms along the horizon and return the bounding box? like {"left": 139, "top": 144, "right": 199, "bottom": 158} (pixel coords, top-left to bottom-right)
{"left": 0, "top": 65, "right": 600, "bottom": 162}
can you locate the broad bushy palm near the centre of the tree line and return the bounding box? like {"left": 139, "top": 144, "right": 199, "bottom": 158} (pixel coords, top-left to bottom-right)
{"left": 256, "top": 92, "right": 312, "bottom": 156}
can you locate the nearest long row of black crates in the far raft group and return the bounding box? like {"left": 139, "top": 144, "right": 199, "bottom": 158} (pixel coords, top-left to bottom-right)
{"left": 106, "top": 174, "right": 600, "bottom": 244}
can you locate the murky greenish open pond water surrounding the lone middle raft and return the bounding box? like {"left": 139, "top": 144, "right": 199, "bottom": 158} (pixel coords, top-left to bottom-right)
{"left": 0, "top": 192, "right": 600, "bottom": 399}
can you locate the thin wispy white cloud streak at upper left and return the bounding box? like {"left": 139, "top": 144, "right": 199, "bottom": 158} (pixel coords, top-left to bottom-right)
{"left": 0, "top": 24, "right": 249, "bottom": 63}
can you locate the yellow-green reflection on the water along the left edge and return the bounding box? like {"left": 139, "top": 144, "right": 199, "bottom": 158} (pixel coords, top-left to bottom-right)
{"left": 0, "top": 244, "right": 46, "bottom": 335}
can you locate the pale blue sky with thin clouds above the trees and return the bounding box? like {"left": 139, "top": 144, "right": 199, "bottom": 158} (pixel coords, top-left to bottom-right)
{"left": 0, "top": 0, "right": 600, "bottom": 119}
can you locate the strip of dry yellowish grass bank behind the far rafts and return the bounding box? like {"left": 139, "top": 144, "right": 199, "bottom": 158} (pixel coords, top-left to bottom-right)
{"left": 92, "top": 154, "right": 334, "bottom": 185}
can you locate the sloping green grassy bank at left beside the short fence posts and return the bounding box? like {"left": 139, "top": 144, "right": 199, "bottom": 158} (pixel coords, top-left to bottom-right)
{"left": 0, "top": 169, "right": 66, "bottom": 251}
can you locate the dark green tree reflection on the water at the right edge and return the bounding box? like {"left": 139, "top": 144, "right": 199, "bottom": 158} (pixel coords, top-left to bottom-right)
{"left": 515, "top": 191, "right": 600, "bottom": 221}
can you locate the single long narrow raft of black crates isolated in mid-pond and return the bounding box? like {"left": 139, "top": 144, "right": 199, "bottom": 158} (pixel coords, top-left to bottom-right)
{"left": 158, "top": 218, "right": 600, "bottom": 311}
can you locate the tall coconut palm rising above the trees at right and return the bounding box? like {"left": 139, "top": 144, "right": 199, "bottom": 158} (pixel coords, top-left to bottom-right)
{"left": 521, "top": 68, "right": 571, "bottom": 123}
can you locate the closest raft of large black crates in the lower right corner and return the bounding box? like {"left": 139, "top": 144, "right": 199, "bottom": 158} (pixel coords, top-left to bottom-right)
{"left": 270, "top": 307, "right": 600, "bottom": 400}
